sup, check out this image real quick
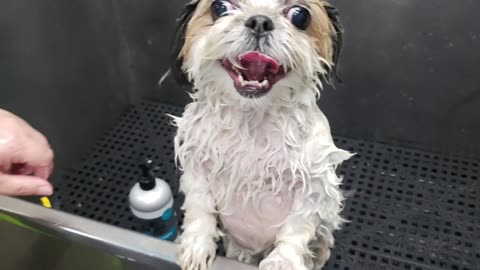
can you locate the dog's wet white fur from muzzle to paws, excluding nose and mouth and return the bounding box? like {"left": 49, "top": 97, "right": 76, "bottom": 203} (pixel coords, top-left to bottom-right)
{"left": 172, "top": 0, "right": 351, "bottom": 270}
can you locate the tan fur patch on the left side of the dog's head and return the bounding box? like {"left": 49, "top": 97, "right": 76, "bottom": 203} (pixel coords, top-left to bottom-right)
{"left": 178, "top": 0, "right": 213, "bottom": 66}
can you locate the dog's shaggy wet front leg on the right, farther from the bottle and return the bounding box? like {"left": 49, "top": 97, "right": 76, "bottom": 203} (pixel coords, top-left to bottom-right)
{"left": 260, "top": 167, "right": 343, "bottom": 270}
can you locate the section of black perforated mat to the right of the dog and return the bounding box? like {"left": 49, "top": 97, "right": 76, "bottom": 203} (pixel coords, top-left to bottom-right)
{"left": 327, "top": 139, "right": 480, "bottom": 270}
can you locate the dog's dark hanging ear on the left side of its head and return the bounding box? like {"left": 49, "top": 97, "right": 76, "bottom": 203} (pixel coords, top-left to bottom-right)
{"left": 170, "top": 0, "right": 200, "bottom": 84}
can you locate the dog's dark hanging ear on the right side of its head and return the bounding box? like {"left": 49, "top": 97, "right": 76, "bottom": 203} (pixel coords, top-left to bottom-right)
{"left": 324, "top": 3, "right": 343, "bottom": 82}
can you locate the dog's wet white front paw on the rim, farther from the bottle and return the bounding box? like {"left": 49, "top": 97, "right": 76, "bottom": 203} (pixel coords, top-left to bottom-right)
{"left": 259, "top": 247, "right": 308, "bottom": 270}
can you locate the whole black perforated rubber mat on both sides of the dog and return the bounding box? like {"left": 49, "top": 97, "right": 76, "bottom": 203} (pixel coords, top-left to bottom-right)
{"left": 52, "top": 101, "right": 480, "bottom": 270}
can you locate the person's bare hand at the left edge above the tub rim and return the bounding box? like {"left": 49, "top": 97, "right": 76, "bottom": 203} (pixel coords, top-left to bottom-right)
{"left": 0, "top": 109, "right": 53, "bottom": 196}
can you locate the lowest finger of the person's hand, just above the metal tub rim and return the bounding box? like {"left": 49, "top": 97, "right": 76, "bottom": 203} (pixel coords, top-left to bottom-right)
{"left": 0, "top": 174, "right": 53, "bottom": 196}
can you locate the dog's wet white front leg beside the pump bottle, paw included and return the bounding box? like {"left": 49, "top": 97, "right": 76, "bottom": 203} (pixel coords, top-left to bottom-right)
{"left": 177, "top": 171, "right": 220, "bottom": 270}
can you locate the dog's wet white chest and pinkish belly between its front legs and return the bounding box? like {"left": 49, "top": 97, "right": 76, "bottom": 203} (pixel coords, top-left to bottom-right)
{"left": 179, "top": 108, "right": 305, "bottom": 254}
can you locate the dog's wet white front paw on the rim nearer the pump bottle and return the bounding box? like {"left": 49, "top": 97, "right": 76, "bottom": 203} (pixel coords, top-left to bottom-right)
{"left": 177, "top": 236, "right": 217, "bottom": 270}
